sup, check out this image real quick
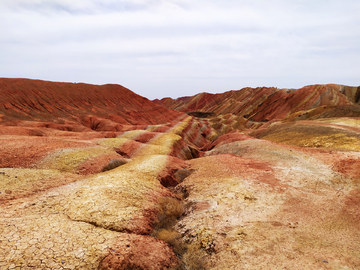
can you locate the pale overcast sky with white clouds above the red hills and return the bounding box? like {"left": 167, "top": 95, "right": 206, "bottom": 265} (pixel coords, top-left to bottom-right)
{"left": 0, "top": 0, "right": 360, "bottom": 99}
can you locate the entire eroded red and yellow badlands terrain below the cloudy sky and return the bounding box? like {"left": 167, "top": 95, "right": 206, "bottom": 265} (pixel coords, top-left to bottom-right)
{"left": 0, "top": 79, "right": 360, "bottom": 269}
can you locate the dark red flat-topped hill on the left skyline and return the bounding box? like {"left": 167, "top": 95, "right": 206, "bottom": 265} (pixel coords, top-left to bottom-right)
{"left": 0, "top": 78, "right": 182, "bottom": 130}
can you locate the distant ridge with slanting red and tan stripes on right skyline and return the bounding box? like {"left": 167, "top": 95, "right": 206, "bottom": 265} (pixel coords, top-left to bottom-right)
{"left": 154, "top": 84, "right": 360, "bottom": 122}
